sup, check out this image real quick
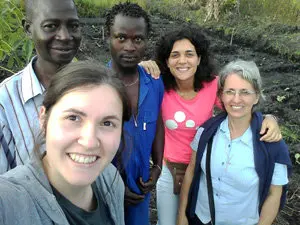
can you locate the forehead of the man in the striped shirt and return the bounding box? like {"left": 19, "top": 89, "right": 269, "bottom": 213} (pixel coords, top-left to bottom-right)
{"left": 33, "top": 0, "right": 78, "bottom": 21}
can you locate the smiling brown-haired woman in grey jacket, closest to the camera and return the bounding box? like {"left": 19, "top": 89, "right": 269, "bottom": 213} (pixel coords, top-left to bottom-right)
{"left": 0, "top": 62, "right": 130, "bottom": 225}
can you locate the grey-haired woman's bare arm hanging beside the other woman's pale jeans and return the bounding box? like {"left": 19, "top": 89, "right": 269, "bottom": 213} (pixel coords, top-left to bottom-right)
{"left": 177, "top": 151, "right": 197, "bottom": 225}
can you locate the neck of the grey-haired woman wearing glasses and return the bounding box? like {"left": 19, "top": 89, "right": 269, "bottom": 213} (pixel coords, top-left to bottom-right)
{"left": 228, "top": 115, "right": 251, "bottom": 140}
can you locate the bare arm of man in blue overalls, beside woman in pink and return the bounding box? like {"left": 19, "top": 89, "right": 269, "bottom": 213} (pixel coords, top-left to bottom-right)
{"left": 139, "top": 112, "right": 165, "bottom": 193}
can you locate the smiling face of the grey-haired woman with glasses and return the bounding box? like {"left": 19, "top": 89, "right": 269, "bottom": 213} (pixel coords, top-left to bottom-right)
{"left": 221, "top": 73, "right": 259, "bottom": 118}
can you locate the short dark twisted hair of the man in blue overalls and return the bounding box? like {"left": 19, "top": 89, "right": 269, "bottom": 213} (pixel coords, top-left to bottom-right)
{"left": 105, "top": 2, "right": 151, "bottom": 36}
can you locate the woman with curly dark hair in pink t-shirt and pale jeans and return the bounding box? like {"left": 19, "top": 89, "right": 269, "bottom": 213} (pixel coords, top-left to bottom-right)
{"left": 149, "top": 25, "right": 281, "bottom": 225}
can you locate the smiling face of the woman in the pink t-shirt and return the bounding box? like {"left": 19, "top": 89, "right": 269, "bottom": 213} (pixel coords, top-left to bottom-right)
{"left": 167, "top": 39, "right": 200, "bottom": 84}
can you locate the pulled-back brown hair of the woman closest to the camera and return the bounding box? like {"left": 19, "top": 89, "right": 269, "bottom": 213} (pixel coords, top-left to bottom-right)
{"left": 34, "top": 61, "right": 131, "bottom": 171}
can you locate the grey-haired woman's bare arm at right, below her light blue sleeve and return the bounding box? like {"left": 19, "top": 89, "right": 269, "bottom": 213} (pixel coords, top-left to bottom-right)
{"left": 258, "top": 185, "right": 282, "bottom": 225}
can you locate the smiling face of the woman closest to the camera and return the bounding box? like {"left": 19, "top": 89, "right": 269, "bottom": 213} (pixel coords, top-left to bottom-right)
{"left": 41, "top": 85, "right": 123, "bottom": 186}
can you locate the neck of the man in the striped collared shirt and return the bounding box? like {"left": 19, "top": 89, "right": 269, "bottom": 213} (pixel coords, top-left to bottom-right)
{"left": 33, "top": 58, "right": 60, "bottom": 89}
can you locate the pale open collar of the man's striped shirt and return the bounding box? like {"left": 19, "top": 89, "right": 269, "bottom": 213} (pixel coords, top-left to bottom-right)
{"left": 21, "top": 56, "right": 45, "bottom": 104}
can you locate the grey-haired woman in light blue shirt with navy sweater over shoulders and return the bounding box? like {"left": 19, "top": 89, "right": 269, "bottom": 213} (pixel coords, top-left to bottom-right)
{"left": 177, "top": 60, "right": 291, "bottom": 225}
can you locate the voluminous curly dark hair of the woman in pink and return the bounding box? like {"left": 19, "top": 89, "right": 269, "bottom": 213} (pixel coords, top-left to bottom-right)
{"left": 155, "top": 24, "right": 216, "bottom": 92}
